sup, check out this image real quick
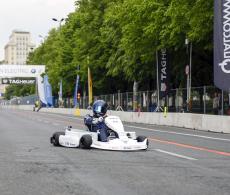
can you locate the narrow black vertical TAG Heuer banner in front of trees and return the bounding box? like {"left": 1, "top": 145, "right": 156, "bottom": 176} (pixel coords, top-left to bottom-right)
{"left": 158, "top": 49, "right": 169, "bottom": 99}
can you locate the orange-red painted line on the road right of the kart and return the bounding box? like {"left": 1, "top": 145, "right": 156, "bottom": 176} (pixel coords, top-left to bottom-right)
{"left": 148, "top": 137, "right": 230, "bottom": 156}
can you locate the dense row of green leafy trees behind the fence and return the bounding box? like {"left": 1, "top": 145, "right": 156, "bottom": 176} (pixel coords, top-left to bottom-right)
{"left": 28, "top": 0, "right": 213, "bottom": 96}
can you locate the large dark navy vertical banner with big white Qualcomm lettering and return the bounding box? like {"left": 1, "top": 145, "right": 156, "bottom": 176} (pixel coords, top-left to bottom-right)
{"left": 214, "top": 0, "right": 230, "bottom": 91}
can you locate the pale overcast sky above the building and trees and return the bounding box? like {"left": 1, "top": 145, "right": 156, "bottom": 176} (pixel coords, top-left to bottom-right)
{"left": 0, "top": 0, "right": 75, "bottom": 60}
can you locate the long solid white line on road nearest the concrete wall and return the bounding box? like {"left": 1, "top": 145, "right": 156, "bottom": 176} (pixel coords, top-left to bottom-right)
{"left": 124, "top": 125, "right": 230, "bottom": 142}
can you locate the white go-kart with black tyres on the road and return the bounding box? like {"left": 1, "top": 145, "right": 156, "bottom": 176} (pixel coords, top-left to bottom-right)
{"left": 50, "top": 116, "right": 148, "bottom": 151}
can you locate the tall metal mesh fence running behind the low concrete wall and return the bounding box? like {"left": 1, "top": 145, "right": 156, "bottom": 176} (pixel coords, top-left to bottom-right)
{"left": 1, "top": 86, "right": 230, "bottom": 115}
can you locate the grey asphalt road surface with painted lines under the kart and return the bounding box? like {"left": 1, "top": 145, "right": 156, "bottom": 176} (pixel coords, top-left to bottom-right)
{"left": 0, "top": 109, "right": 230, "bottom": 195}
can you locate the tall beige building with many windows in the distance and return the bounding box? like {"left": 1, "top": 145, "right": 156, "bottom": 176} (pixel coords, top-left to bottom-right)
{"left": 4, "top": 30, "right": 35, "bottom": 65}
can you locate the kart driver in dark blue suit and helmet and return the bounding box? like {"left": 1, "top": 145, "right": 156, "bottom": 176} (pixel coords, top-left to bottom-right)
{"left": 84, "top": 100, "right": 109, "bottom": 142}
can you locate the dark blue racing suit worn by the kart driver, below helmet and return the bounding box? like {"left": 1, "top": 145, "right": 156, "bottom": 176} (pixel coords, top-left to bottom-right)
{"left": 84, "top": 114, "right": 109, "bottom": 142}
